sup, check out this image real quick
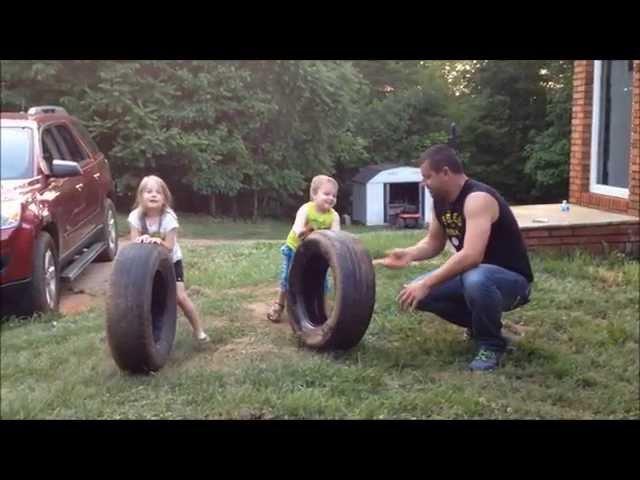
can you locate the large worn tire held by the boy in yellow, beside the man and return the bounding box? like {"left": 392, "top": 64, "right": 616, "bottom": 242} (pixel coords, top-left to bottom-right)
{"left": 287, "top": 230, "right": 376, "bottom": 350}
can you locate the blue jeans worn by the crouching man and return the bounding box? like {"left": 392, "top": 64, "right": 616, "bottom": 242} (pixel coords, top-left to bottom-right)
{"left": 414, "top": 263, "right": 531, "bottom": 351}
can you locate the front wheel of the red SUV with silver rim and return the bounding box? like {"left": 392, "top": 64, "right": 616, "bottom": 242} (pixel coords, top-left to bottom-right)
{"left": 21, "top": 232, "right": 60, "bottom": 315}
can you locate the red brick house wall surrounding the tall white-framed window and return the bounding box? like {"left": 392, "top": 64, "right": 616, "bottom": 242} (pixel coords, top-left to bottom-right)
{"left": 569, "top": 60, "right": 640, "bottom": 217}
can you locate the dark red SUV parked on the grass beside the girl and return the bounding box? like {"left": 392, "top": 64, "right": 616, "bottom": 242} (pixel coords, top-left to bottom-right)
{"left": 0, "top": 107, "right": 118, "bottom": 314}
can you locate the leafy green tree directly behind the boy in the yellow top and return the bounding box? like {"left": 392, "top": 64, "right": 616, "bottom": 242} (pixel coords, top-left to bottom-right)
{"left": 241, "top": 61, "right": 366, "bottom": 218}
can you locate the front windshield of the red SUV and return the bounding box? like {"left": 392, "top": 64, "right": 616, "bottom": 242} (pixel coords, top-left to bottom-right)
{"left": 0, "top": 127, "right": 33, "bottom": 180}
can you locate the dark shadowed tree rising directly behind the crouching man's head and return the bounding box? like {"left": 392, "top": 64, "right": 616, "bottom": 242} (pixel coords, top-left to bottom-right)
{"left": 459, "top": 60, "right": 547, "bottom": 202}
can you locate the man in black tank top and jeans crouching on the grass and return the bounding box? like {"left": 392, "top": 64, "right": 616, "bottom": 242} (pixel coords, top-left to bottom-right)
{"left": 382, "top": 145, "right": 533, "bottom": 371}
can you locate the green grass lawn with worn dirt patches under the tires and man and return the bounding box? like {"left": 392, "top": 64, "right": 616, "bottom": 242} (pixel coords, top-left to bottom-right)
{"left": 0, "top": 219, "right": 640, "bottom": 419}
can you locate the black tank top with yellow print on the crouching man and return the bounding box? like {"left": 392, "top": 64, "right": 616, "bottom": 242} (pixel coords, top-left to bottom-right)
{"left": 433, "top": 178, "right": 533, "bottom": 282}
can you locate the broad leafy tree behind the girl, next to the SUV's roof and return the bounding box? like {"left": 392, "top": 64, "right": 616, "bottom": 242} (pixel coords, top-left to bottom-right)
{"left": 62, "top": 61, "right": 267, "bottom": 210}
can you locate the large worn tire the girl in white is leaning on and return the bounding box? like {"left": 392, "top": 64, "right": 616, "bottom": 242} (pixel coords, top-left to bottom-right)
{"left": 107, "top": 243, "right": 177, "bottom": 373}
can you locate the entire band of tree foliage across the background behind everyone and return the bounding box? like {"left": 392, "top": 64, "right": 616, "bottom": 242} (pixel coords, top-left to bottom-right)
{"left": 1, "top": 60, "right": 571, "bottom": 213}
